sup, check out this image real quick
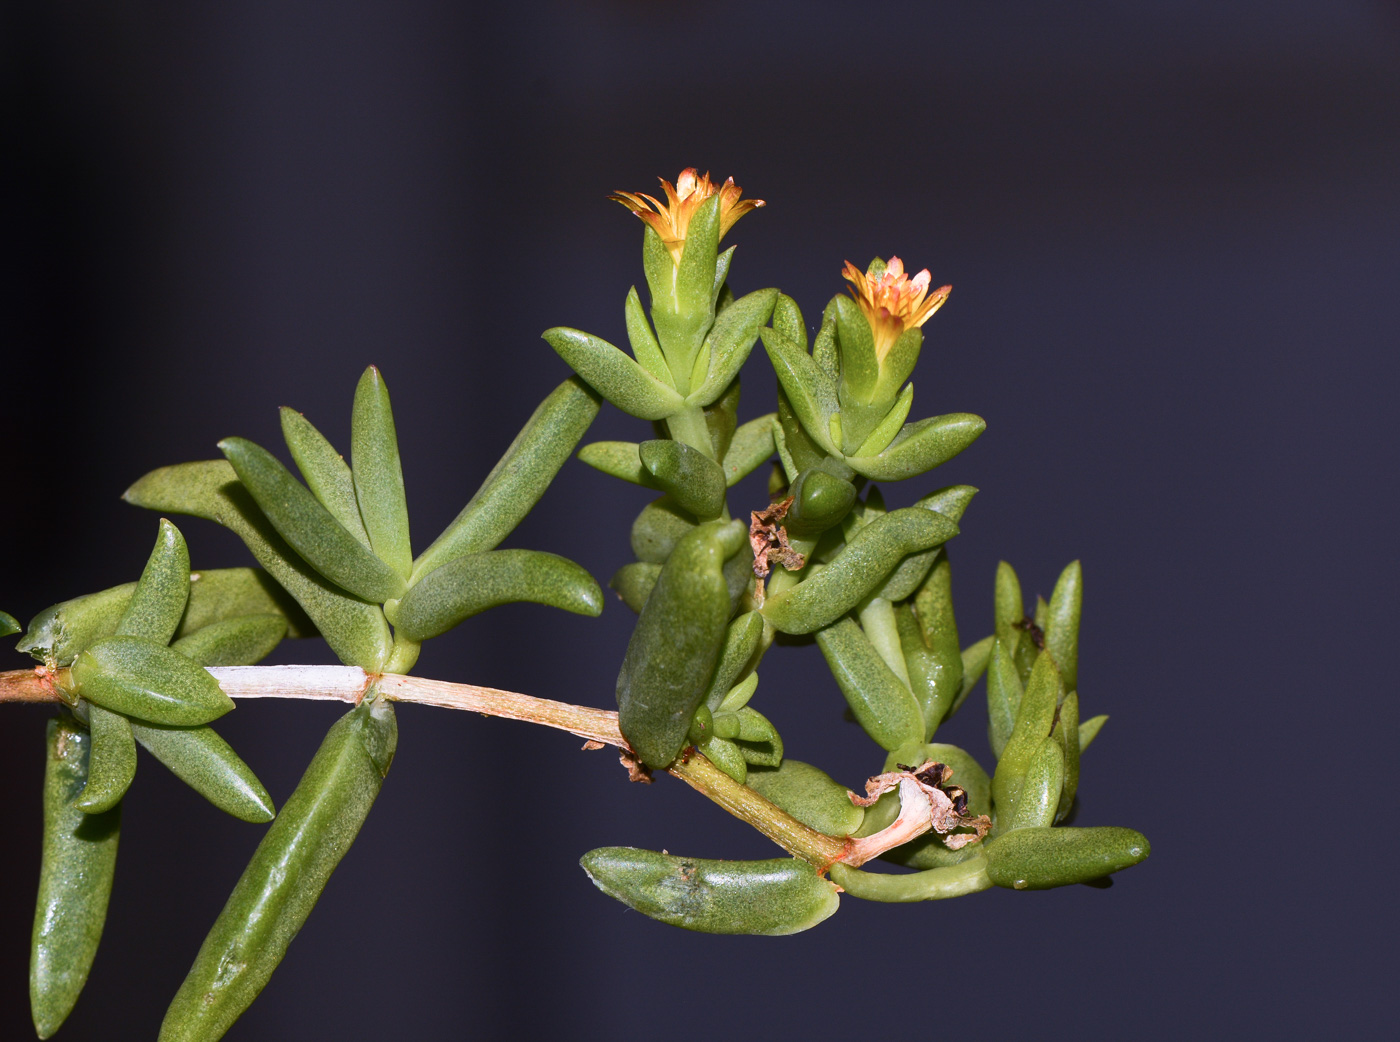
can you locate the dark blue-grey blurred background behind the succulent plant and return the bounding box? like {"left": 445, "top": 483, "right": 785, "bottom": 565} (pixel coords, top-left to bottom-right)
{"left": 0, "top": 0, "right": 1400, "bottom": 1041}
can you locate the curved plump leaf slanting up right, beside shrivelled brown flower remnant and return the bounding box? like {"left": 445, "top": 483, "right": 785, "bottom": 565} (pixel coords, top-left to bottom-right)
{"left": 762, "top": 507, "right": 958, "bottom": 633}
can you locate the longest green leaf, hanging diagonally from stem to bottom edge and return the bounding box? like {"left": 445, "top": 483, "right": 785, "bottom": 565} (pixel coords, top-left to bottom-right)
{"left": 160, "top": 697, "right": 398, "bottom": 1042}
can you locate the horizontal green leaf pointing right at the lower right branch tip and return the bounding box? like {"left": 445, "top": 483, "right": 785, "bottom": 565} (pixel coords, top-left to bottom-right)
{"left": 987, "top": 828, "right": 1152, "bottom": 889}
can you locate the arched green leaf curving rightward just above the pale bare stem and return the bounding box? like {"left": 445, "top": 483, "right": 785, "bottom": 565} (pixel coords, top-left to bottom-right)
{"left": 398, "top": 550, "right": 603, "bottom": 640}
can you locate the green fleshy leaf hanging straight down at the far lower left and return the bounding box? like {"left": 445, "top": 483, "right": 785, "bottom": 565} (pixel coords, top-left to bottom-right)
{"left": 29, "top": 720, "right": 122, "bottom": 1038}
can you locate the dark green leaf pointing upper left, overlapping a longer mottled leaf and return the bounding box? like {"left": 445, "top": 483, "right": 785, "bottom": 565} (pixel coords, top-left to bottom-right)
{"left": 218, "top": 438, "right": 407, "bottom": 602}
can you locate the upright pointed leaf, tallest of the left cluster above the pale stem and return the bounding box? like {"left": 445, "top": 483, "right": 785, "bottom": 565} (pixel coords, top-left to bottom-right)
{"left": 350, "top": 366, "right": 413, "bottom": 578}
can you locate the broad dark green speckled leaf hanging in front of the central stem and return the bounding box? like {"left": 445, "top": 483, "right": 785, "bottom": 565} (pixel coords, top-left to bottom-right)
{"left": 617, "top": 521, "right": 745, "bottom": 769}
